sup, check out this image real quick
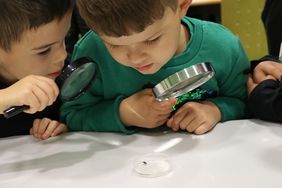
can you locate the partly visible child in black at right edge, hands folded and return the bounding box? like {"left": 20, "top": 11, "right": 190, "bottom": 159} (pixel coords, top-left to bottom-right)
{"left": 248, "top": 0, "right": 282, "bottom": 122}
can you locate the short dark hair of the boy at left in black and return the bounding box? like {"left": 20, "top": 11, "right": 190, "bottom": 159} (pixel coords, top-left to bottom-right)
{"left": 0, "top": 0, "right": 74, "bottom": 51}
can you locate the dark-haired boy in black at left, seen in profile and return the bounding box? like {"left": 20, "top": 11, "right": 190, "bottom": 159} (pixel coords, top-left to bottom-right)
{"left": 0, "top": 0, "right": 74, "bottom": 139}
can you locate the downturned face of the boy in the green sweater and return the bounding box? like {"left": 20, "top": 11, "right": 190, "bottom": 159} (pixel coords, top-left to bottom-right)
{"left": 101, "top": 8, "right": 186, "bottom": 74}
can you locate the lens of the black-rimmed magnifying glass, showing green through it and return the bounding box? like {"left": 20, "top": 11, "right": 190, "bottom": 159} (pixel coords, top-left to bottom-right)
{"left": 60, "top": 63, "right": 96, "bottom": 101}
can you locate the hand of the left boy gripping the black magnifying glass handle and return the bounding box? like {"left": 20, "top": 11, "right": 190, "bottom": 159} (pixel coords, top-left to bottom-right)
{"left": 0, "top": 75, "right": 59, "bottom": 114}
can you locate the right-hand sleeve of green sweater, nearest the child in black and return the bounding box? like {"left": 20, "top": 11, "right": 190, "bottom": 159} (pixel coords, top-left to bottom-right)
{"left": 210, "top": 40, "right": 250, "bottom": 121}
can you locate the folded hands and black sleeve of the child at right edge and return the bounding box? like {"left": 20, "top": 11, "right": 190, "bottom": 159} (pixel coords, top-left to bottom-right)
{"left": 248, "top": 57, "right": 282, "bottom": 122}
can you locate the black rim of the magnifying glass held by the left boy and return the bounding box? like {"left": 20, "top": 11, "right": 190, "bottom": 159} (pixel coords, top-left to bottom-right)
{"left": 56, "top": 57, "right": 98, "bottom": 102}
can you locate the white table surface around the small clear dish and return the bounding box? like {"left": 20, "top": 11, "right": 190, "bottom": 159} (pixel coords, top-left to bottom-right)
{"left": 0, "top": 120, "right": 282, "bottom": 188}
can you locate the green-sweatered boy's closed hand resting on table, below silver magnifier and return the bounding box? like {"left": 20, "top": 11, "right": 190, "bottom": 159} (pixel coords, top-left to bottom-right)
{"left": 167, "top": 101, "right": 221, "bottom": 134}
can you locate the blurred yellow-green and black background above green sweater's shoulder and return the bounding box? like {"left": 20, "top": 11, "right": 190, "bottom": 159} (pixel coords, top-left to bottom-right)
{"left": 187, "top": 0, "right": 268, "bottom": 59}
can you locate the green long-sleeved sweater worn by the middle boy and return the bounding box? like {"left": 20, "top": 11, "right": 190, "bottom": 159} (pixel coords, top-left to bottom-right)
{"left": 61, "top": 17, "right": 249, "bottom": 134}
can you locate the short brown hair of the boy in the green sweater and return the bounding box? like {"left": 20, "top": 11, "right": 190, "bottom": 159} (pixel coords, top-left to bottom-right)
{"left": 76, "top": 0, "right": 178, "bottom": 37}
